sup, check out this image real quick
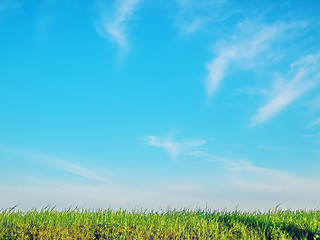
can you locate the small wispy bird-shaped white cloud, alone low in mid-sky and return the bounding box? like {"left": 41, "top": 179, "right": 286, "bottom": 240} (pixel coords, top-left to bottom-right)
{"left": 146, "top": 134, "right": 206, "bottom": 158}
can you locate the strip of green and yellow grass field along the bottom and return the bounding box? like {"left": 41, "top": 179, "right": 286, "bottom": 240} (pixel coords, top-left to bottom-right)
{"left": 0, "top": 208, "right": 320, "bottom": 239}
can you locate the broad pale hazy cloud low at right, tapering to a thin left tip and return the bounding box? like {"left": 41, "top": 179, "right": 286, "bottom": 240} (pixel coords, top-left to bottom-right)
{"left": 197, "top": 149, "right": 320, "bottom": 202}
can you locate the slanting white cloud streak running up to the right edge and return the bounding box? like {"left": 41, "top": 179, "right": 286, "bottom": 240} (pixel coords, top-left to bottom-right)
{"left": 251, "top": 54, "right": 320, "bottom": 127}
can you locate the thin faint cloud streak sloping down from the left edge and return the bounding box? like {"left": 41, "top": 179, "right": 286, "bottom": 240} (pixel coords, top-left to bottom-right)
{"left": 0, "top": 146, "right": 107, "bottom": 182}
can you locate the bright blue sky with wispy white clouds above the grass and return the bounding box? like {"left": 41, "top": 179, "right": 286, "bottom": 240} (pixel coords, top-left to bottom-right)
{"left": 0, "top": 0, "right": 320, "bottom": 211}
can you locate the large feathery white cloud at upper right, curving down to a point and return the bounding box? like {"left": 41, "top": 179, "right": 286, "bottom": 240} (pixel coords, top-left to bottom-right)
{"left": 205, "top": 21, "right": 308, "bottom": 97}
